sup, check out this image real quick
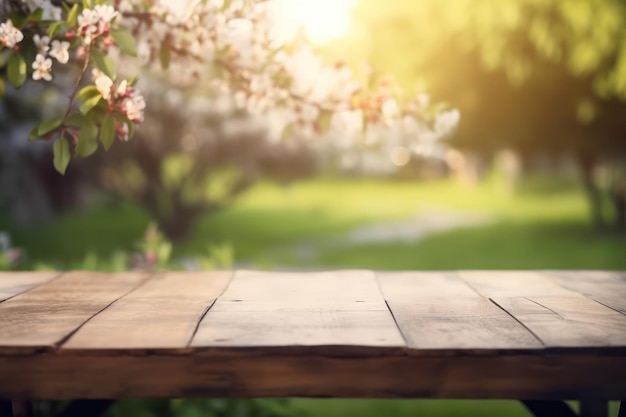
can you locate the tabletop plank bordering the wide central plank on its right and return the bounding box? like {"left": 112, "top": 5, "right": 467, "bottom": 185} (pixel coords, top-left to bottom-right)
{"left": 377, "top": 272, "right": 543, "bottom": 351}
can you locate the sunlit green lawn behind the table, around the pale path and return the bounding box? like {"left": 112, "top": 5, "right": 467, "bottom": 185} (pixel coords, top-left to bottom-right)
{"left": 0, "top": 174, "right": 626, "bottom": 270}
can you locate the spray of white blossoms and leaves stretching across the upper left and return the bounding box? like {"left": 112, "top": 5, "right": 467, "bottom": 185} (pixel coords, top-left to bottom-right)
{"left": 0, "top": 0, "right": 458, "bottom": 171}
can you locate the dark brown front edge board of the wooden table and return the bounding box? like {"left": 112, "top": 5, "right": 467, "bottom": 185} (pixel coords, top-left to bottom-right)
{"left": 0, "top": 352, "right": 626, "bottom": 400}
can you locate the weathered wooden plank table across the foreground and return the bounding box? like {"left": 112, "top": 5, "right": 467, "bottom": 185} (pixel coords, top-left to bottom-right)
{"left": 0, "top": 271, "right": 626, "bottom": 415}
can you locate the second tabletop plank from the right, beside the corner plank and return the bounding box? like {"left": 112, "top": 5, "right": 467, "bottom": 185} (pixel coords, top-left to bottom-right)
{"left": 460, "top": 271, "right": 626, "bottom": 348}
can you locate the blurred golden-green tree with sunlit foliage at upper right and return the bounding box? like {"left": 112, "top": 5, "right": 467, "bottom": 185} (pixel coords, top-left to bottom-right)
{"left": 344, "top": 0, "right": 626, "bottom": 225}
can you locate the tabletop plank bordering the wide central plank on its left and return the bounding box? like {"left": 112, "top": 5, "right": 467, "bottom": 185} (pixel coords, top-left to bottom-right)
{"left": 62, "top": 272, "right": 233, "bottom": 351}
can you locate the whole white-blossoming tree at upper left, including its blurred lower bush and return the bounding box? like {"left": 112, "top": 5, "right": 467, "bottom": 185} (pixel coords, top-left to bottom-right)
{"left": 0, "top": 0, "right": 458, "bottom": 239}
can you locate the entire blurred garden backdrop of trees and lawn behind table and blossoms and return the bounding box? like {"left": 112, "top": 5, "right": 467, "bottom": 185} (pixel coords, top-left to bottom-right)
{"left": 0, "top": 0, "right": 626, "bottom": 417}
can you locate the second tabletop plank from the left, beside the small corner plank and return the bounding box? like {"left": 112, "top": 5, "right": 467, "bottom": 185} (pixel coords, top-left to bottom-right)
{"left": 0, "top": 272, "right": 147, "bottom": 354}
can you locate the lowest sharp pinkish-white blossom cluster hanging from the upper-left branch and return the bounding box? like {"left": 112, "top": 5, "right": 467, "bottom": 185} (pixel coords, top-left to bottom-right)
{"left": 92, "top": 69, "right": 146, "bottom": 123}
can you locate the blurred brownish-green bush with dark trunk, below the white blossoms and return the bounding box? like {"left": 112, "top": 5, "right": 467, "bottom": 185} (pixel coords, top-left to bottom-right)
{"left": 100, "top": 84, "right": 316, "bottom": 240}
